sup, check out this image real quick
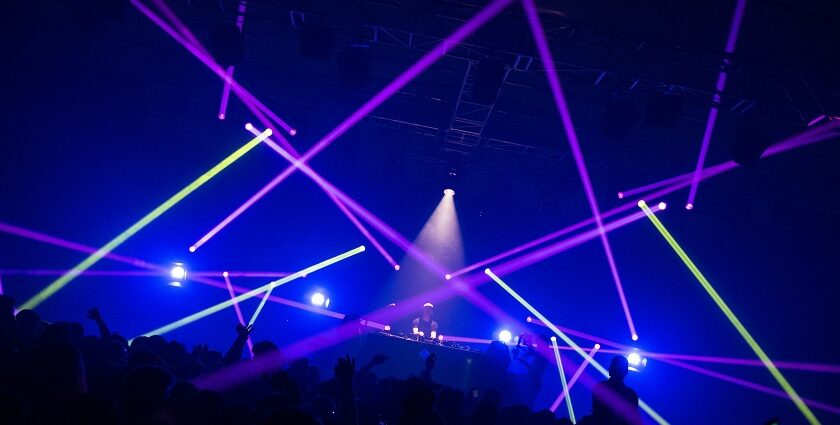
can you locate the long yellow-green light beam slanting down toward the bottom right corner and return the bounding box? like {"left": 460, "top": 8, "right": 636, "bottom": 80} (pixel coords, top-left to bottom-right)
{"left": 639, "top": 201, "right": 820, "bottom": 425}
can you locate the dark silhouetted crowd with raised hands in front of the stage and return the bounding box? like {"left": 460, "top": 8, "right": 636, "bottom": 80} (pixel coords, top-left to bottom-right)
{"left": 0, "top": 296, "right": 641, "bottom": 425}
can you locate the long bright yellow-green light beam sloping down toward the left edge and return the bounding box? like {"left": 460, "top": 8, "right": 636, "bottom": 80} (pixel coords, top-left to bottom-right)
{"left": 20, "top": 130, "right": 271, "bottom": 309}
